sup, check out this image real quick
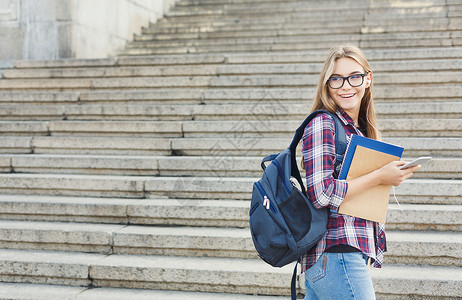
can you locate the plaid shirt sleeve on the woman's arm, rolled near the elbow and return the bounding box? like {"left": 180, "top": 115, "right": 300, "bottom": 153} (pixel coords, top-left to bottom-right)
{"left": 302, "top": 114, "right": 348, "bottom": 209}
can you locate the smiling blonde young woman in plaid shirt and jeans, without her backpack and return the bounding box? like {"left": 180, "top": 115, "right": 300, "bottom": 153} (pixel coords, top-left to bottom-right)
{"left": 301, "top": 46, "right": 419, "bottom": 300}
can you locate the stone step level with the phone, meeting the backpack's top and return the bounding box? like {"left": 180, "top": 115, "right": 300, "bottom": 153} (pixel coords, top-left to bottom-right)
{"left": 0, "top": 154, "right": 462, "bottom": 179}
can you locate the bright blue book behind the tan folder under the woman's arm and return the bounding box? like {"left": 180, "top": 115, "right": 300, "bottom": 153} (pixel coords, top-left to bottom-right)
{"left": 338, "top": 134, "right": 404, "bottom": 179}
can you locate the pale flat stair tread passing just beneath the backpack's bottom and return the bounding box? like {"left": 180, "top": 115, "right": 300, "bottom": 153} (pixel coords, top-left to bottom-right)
{"left": 0, "top": 249, "right": 462, "bottom": 281}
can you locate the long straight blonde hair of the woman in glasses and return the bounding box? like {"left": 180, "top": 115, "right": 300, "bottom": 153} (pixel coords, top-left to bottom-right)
{"left": 311, "top": 46, "right": 380, "bottom": 140}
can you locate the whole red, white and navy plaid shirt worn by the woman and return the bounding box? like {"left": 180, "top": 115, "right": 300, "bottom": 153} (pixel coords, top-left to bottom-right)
{"left": 300, "top": 111, "right": 386, "bottom": 272}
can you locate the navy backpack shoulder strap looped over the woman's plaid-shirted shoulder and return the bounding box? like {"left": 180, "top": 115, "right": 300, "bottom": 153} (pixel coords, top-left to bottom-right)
{"left": 289, "top": 110, "right": 347, "bottom": 196}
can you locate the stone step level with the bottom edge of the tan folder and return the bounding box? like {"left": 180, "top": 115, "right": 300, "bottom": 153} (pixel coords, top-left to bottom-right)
{"left": 0, "top": 194, "right": 462, "bottom": 232}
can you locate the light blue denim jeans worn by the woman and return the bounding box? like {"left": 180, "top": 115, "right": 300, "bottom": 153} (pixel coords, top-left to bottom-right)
{"left": 305, "top": 252, "right": 375, "bottom": 300}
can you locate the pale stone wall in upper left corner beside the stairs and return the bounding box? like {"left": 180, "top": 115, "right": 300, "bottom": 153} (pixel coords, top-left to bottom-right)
{"left": 0, "top": 0, "right": 175, "bottom": 62}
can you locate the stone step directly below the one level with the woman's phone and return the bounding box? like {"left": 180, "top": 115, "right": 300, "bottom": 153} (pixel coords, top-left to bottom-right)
{"left": 0, "top": 173, "right": 456, "bottom": 205}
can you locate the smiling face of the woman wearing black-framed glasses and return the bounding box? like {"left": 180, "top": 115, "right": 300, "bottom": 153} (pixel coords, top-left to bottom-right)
{"left": 327, "top": 57, "right": 372, "bottom": 124}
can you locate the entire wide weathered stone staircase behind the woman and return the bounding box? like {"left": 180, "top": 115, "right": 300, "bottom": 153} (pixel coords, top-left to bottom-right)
{"left": 0, "top": 0, "right": 462, "bottom": 300}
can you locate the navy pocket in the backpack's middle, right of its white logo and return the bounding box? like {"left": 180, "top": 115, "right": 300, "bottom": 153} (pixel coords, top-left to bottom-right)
{"left": 278, "top": 188, "right": 311, "bottom": 242}
